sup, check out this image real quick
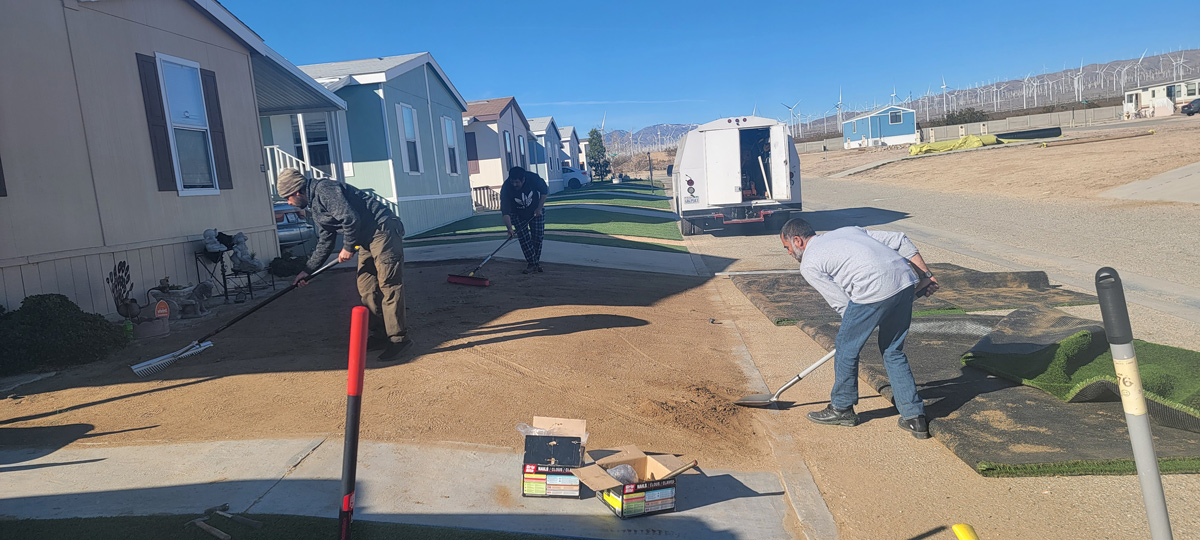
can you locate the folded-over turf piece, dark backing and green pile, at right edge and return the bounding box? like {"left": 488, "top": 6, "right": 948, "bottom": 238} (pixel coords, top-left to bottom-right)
{"left": 962, "top": 308, "right": 1200, "bottom": 433}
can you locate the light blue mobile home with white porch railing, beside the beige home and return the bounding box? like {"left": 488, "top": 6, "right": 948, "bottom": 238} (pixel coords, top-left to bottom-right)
{"left": 263, "top": 53, "right": 474, "bottom": 234}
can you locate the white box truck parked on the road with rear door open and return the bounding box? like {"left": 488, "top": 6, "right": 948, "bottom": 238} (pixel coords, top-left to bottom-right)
{"left": 667, "top": 116, "right": 800, "bottom": 236}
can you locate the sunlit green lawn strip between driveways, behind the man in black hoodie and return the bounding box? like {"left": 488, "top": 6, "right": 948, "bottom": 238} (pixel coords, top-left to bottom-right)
{"left": 412, "top": 208, "right": 683, "bottom": 240}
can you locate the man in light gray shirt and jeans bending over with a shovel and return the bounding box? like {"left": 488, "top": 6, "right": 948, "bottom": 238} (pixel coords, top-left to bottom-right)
{"left": 780, "top": 218, "right": 938, "bottom": 439}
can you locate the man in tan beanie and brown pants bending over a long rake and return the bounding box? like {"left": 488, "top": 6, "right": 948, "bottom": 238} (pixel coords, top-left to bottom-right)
{"left": 276, "top": 169, "right": 413, "bottom": 360}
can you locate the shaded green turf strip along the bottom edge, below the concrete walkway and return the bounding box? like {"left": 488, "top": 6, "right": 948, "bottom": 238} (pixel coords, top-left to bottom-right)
{"left": 0, "top": 515, "right": 558, "bottom": 540}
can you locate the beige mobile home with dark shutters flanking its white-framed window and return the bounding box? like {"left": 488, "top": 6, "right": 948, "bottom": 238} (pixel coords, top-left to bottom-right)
{"left": 0, "top": 0, "right": 344, "bottom": 313}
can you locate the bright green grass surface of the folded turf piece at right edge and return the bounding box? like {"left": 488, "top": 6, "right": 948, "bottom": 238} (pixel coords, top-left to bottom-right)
{"left": 962, "top": 331, "right": 1200, "bottom": 418}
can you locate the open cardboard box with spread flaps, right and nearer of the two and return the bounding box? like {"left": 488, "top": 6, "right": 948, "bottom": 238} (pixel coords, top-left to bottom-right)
{"left": 574, "top": 446, "right": 684, "bottom": 518}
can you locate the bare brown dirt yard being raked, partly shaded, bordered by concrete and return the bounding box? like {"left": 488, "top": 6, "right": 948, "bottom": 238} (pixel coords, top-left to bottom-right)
{"left": 0, "top": 260, "right": 769, "bottom": 469}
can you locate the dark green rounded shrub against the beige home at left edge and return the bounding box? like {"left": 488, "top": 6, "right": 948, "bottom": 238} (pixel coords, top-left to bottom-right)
{"left": 0, "top": 294, "right": 128, "bottom": 376}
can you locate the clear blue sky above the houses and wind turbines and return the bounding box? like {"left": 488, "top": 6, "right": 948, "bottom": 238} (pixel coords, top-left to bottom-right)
{"left": 222, "top": 0, "right": 1200, "bottom": 134}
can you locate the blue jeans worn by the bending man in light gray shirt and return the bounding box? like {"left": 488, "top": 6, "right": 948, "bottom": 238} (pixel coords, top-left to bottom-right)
{"left": 829, "top": 287, "right": 925, "bottom": 419}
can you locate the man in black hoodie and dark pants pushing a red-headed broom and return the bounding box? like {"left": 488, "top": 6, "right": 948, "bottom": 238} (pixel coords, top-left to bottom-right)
{"left": 500, "top": 167, "right": 550, "bottom": 274}
